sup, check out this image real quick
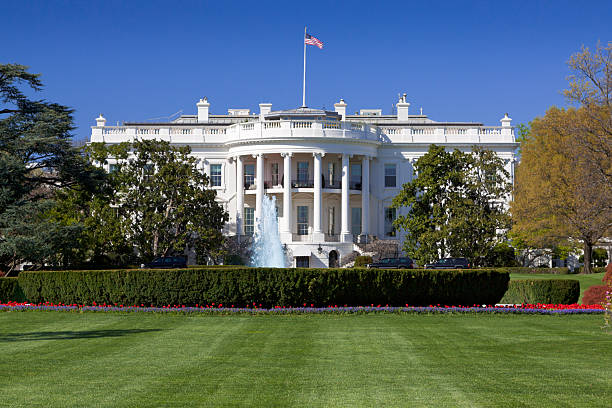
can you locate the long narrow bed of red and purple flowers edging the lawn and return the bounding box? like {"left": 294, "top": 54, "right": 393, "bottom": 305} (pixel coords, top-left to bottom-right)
{"left": 0, "top": 302, "right": 604, "bottom": 315}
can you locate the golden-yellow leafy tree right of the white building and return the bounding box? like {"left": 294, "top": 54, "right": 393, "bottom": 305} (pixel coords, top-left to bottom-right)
{"left": 512, "top": 107, "right": 612, "bottom": 273}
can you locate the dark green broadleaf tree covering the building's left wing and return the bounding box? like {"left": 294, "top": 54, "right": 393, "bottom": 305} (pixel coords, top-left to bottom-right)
{"left": 90, "top": 140, "right": 229, "bottom": 261}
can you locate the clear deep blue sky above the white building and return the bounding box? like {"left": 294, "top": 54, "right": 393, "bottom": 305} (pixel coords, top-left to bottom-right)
{"left": 0, "top": 0, "right": 612, "bottom": 139}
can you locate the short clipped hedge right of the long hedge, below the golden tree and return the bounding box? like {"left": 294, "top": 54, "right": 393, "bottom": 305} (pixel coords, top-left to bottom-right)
{"left": 500, "top": 279, "right": 580, "bottom": 305}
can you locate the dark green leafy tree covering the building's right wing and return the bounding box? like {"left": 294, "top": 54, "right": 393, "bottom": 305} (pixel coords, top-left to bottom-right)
{"left": 393, "top": 145, "right": 511, "bottom": 264}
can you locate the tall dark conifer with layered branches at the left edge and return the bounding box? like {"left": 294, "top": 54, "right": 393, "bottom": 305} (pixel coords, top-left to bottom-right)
{"left": 0, "top": 64, "right": 104, "bottom": 273}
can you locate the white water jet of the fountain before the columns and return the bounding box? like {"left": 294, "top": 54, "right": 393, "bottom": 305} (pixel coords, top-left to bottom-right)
{"left": 251, "top": 194, "right": 286, "bottom": 268}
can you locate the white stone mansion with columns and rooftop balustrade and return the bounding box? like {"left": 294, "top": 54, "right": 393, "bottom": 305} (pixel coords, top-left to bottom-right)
{"left": 91, "top": 94, "right": 517, "bottom": 267}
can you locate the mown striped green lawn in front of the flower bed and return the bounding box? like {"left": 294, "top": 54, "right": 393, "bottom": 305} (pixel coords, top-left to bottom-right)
{"left": 0, "top": 312, "right": 612, "bottom": 407}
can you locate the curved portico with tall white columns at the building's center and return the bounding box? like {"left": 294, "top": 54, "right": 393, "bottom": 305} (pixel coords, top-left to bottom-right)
{"left": 231, "top": 151, "right": 371, "bottom": 243}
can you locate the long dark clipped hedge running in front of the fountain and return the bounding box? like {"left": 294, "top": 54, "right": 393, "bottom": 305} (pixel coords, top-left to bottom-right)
{"left": 19, "top": 267, "right": 509, "bottom": 307}
